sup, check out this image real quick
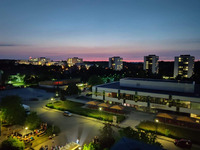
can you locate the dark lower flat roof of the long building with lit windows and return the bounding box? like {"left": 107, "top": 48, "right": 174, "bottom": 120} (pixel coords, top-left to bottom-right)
{"left": 96, "top": 81, "right": 200, "bottom": 98}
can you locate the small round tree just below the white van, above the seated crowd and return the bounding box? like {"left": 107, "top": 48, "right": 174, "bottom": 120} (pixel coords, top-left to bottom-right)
{"left": 25, "top": 112, "right": 41, "bottom": 130}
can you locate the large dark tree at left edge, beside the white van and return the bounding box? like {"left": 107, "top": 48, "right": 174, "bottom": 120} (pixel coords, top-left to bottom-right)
{"left": 0, "top": 96, "right": 26, "bottom": 124}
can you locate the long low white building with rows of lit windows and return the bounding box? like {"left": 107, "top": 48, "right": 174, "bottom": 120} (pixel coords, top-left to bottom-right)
{"left": 92, "top": 78, "right": 200, "bottom": 117}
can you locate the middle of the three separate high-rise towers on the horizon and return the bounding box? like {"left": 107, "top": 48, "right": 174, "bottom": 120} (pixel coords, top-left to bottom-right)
{"left": 143, "top": 55, "right": 159, "bottom": 74}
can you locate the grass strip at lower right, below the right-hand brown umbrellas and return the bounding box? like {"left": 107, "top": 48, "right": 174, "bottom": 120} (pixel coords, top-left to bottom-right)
{"left": 137, "top": 121, "right": 200, "bottom": 143}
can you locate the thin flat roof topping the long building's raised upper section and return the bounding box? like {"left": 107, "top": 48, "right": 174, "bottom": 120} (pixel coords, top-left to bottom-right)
{"left": 122, "top": 78, "right": 193, "bottom": 84}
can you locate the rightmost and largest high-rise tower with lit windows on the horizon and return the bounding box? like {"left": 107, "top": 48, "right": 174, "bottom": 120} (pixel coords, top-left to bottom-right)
{"left": 174, "top": 55, "right": 195, "bottom": 78}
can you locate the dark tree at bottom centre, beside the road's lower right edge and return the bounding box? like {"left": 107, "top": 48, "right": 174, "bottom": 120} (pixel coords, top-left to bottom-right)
{"left": 99, "top": 124, "right": 115, "bottom": 149}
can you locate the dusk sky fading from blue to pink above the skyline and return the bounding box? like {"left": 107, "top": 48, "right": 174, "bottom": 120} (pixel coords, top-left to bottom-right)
{"left": 0, "top": 0, "right": 200, "bottom": 62}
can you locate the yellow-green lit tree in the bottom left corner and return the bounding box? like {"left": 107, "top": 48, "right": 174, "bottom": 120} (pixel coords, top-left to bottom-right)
{"left": 1, "top": 137, "right": 25, "bottom": 150}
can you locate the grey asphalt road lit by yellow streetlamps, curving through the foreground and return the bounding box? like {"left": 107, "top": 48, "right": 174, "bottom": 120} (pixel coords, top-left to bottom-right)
{"left": 25, "top": 101, "right": 200, "bottom": 150}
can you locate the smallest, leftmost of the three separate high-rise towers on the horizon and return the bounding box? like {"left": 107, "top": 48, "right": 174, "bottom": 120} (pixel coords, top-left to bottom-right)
{"left": 109, "top": 56, "right": 123, "bottom": 71}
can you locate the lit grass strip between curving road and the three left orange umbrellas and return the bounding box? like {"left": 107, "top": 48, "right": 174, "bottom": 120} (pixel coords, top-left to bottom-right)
{"left": 46, "top": 101, "right": 125, "bottom": 122}
